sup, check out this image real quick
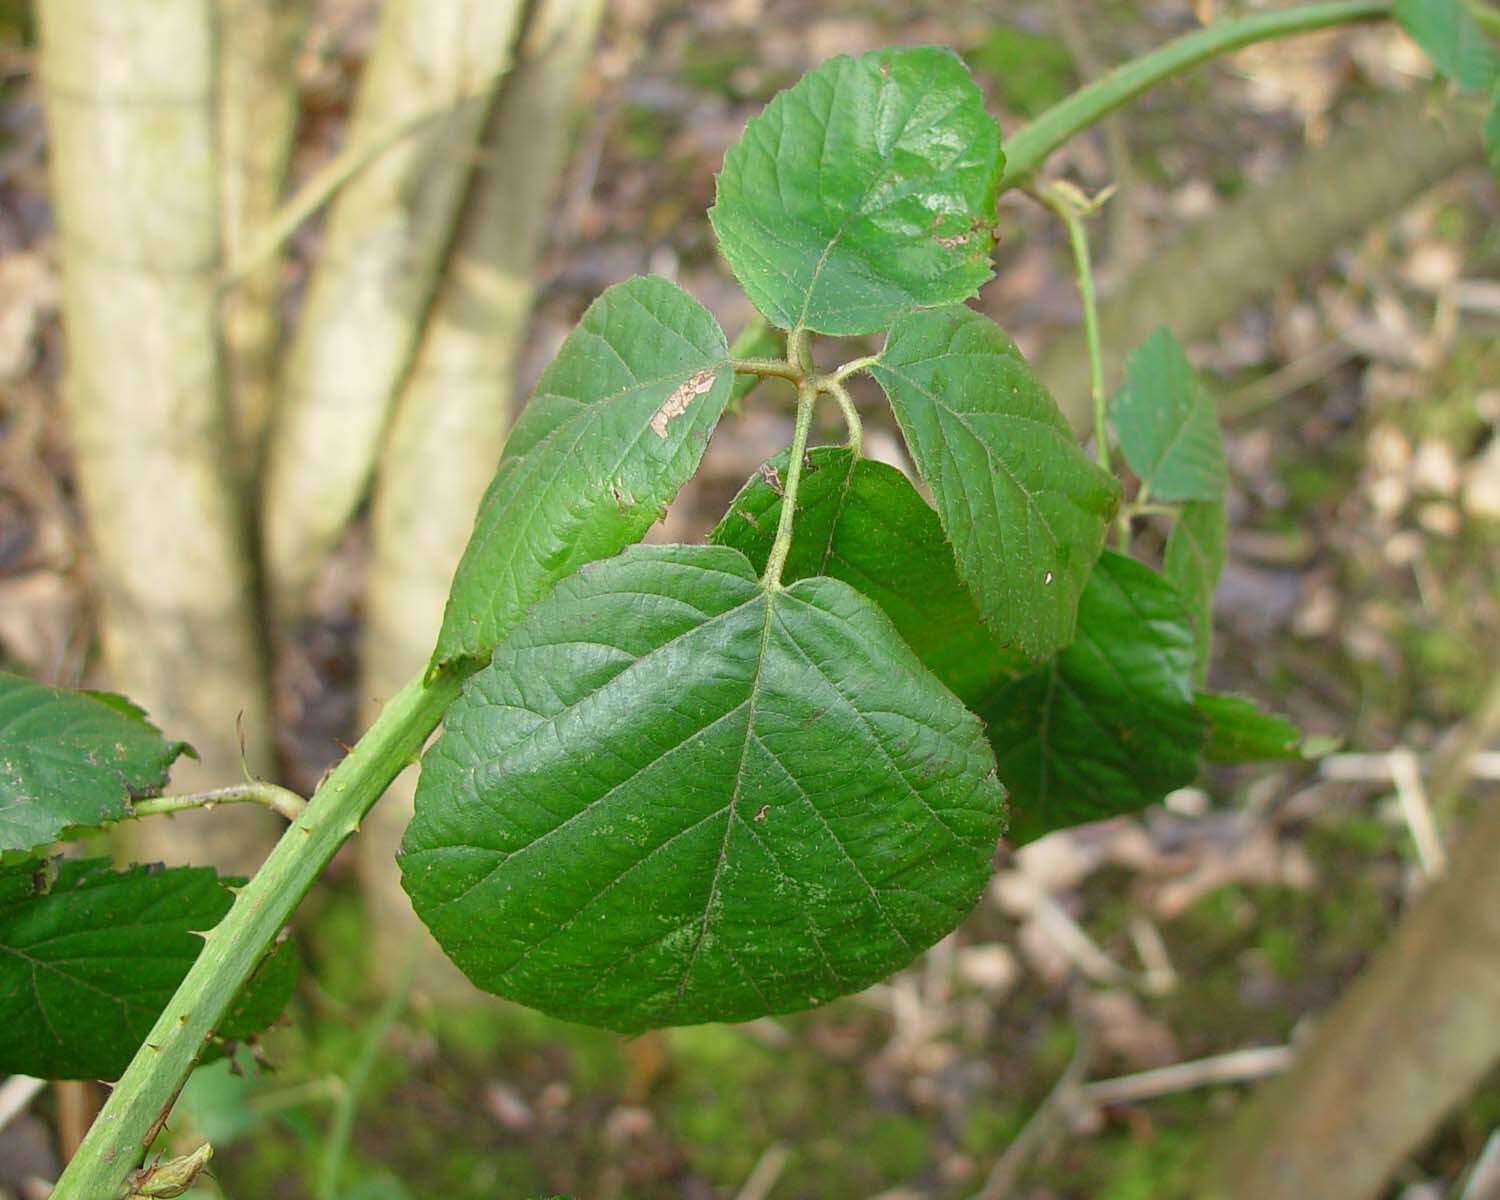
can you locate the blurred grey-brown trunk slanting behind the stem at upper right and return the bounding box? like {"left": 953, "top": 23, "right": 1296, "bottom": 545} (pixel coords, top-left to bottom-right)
{"left": 1037, "top": 93, "right": 1484, "bottom": 431}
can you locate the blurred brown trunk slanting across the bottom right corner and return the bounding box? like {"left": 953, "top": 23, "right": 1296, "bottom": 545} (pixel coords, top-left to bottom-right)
{"left": 1206, "top": 801, "right": 1500, "bottom": 1200}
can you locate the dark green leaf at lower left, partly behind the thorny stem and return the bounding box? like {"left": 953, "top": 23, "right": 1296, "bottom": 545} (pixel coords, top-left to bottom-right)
{"left": 0, "top": 858, "right": 294, "bottom": 1079}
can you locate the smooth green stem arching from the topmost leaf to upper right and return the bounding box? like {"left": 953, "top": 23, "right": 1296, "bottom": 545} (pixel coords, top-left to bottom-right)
{"left": 1001, "top": 0, "right": 1392, "bottom": 191}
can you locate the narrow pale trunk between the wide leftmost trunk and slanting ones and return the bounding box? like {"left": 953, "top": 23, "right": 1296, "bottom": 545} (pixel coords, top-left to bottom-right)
{"left": 219, "top": 0, "right": 309, "bottom": 477}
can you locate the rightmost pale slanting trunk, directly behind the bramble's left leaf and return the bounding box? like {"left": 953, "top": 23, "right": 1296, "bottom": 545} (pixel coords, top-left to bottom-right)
{"left": 357, "top": 0, "right": 602, "bottom": 989}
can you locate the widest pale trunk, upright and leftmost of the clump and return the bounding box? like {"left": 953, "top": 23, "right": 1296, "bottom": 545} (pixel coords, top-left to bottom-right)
{"left": 38, "top": 0, "right": 272, "bottom": 869}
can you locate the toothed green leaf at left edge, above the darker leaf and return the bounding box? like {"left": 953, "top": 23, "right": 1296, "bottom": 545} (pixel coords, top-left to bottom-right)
{"left": 0, "top": 672, "right": 191, "bottom": 852}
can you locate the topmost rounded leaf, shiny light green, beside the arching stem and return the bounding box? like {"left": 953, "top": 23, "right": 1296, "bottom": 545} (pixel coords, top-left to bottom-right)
{"left": 708, "top": 47, "right": 1005, "bottom": 335}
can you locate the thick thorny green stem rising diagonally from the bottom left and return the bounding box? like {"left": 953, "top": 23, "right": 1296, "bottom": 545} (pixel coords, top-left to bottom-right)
{"left": 53, "top": 668, "right": 464, "bottom": 1200}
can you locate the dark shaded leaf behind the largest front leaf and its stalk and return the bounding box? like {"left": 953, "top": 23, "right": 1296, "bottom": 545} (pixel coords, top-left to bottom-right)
{"left": 708, "top": 446, "right": 1028, "bottom": 714}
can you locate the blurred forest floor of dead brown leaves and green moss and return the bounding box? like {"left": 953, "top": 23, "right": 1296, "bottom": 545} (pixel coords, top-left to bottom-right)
{"left": 0, "top": 0, "right": 1500, "bottom": 1200}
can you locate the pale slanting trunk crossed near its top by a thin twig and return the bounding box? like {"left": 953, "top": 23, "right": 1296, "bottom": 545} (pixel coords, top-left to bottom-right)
{"left": 263, "top": 0, "right": 522, "bottom": 621}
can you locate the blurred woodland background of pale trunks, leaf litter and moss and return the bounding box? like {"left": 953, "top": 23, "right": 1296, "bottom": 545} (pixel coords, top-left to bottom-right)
{"left": 0, "top": 0, "right": 1500, "bottom": 1200}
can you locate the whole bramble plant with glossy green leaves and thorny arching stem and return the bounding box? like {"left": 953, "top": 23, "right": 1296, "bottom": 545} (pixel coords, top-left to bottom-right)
{"left": 0, "top": 0, "right": 1500, "bottom": 1200}
